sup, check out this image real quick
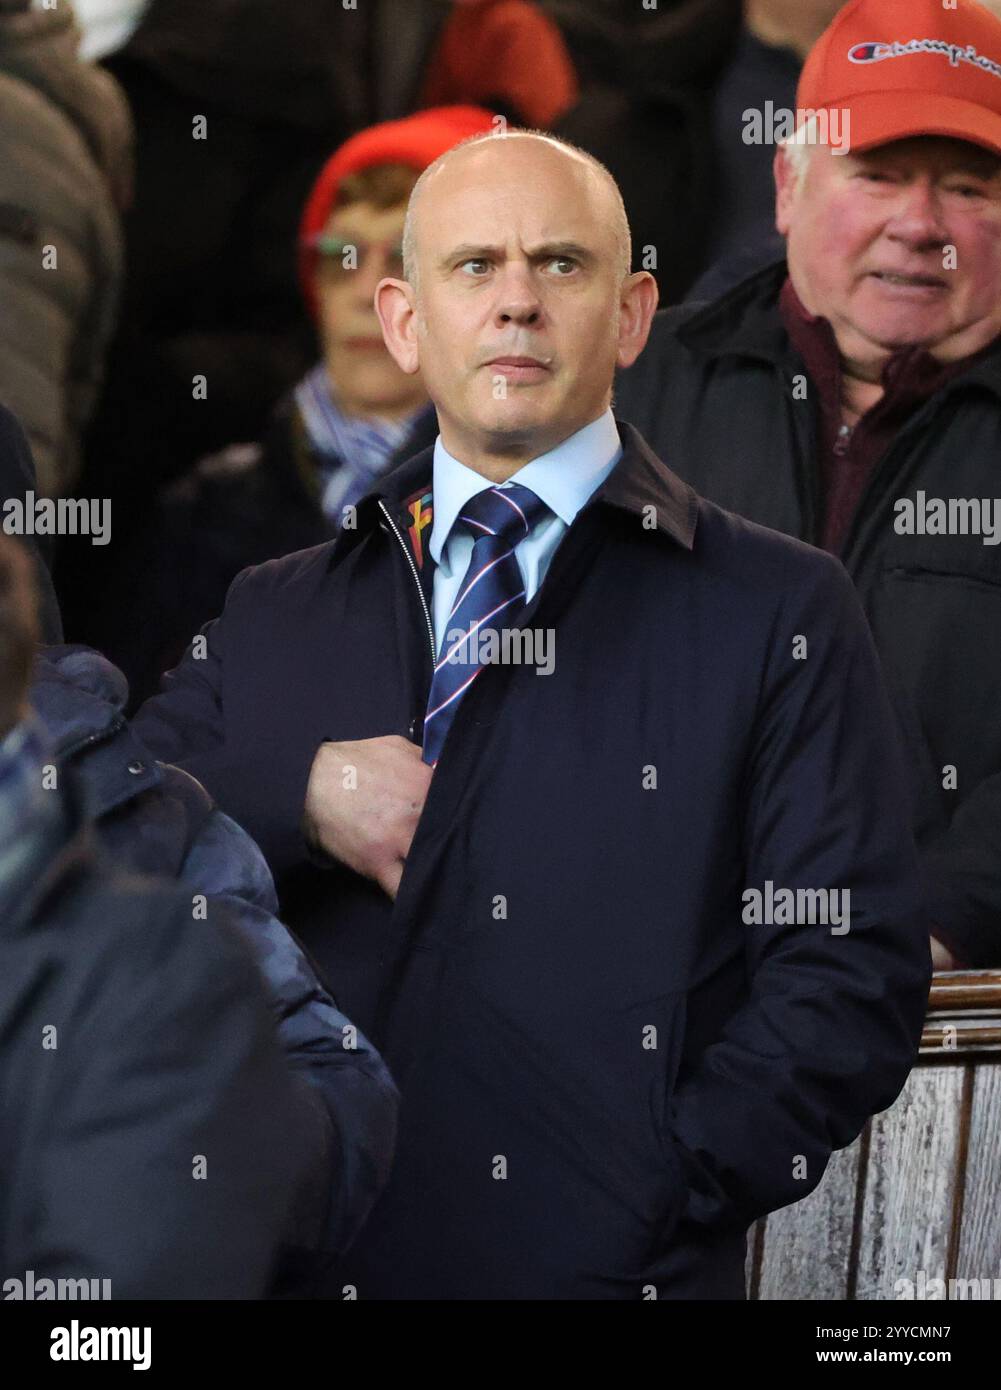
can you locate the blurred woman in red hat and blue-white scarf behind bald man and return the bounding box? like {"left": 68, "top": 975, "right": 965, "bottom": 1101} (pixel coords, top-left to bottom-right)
{"left": 121, "top": 106, "right": 492, "bottom": 701}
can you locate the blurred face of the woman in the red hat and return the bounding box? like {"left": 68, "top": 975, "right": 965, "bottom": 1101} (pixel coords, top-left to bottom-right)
{"left": 316, "top": 203, "right": 427, "bottom": 418}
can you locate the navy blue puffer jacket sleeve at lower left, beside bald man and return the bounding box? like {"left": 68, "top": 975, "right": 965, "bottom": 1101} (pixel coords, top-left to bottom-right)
{"left": 31, "top": 646, "right": 399, "bottom": 1280}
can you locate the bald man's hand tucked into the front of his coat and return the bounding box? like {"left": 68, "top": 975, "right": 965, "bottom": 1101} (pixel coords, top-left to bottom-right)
{"left": 303, "top": 734, "right": 431, "bottom": 899}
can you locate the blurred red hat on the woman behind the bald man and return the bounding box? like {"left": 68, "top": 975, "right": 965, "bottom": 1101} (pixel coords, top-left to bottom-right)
{"left": 299, "top": 106, "right": 494, "bottom": 318}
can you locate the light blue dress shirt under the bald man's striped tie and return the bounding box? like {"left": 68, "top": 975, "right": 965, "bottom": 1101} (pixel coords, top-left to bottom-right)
{"left": 430, "top": 410, "right": 621, "bottom": 651}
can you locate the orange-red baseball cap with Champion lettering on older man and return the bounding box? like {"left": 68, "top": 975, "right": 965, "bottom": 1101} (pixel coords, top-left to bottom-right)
{"left": 797, "top": 0, "right": 1001, "bottom": 154}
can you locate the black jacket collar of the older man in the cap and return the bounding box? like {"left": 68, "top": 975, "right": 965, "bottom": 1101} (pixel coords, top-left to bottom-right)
{"left": 677, "top": 257, "right": 1001, "bottom": 399}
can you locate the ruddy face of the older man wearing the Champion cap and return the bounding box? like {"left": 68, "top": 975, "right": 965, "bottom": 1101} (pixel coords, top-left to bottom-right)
{"left": 776, "top": 136, "right": 1001, "bottom": 361}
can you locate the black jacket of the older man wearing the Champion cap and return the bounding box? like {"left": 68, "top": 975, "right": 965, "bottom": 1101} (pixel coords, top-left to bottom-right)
{"left": 616, "top": 261, "right": 1001, "bottom": 966}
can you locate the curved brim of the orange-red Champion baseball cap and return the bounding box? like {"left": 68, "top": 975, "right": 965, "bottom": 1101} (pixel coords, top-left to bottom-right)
{"left": 830, "top": 92, "right": 1001, "bottom": 156}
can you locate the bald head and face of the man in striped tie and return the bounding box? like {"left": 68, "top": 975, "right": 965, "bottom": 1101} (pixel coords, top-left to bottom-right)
{"left": 384, "top": 138, "right": 652, "bottom": 457}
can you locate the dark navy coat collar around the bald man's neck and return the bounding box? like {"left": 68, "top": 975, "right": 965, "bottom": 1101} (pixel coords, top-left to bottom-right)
{"left": 329, "top": 420, "right": 698, "bottom": 564}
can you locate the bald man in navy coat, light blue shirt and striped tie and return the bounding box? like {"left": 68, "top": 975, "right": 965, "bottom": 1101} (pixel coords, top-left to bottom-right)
{"left": 136, "top": 132, "right": 930, "bottom": 1300}
